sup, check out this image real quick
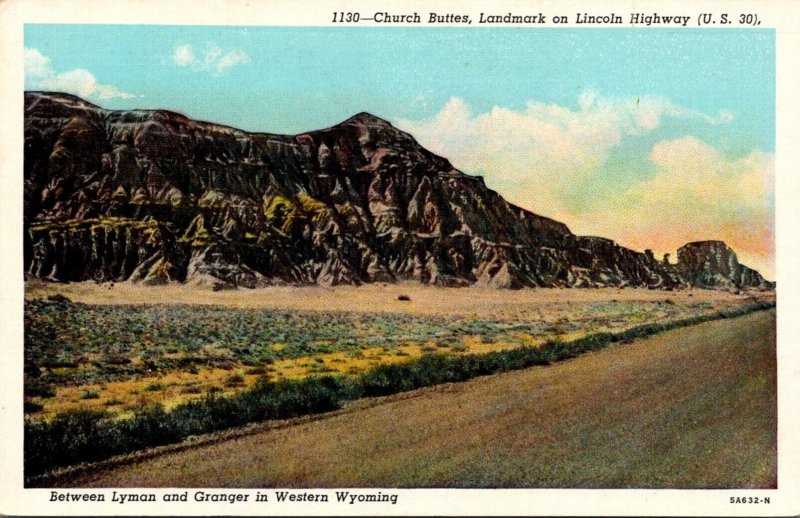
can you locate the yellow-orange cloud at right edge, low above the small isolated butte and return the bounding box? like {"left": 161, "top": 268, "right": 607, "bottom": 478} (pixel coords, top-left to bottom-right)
{"left": 581, "top": 136, "right": 775, "bottom": 278}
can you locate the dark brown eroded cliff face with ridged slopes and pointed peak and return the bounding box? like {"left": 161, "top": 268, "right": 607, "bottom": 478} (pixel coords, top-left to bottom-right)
{"left": 24, "top": 92, "right": 765, "bottom": 288}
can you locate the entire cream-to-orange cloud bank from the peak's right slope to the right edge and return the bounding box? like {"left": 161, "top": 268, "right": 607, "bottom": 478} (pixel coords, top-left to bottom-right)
{"left": 397, "top": 91, "right": 774, "bottom": 275}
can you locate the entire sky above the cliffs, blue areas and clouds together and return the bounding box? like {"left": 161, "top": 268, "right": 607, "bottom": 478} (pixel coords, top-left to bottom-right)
{"left": 25, "top": 25, "right": 775, "bottom": 279}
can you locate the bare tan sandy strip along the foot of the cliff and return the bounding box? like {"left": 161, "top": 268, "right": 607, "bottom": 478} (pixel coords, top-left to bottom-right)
{"left": 25, "top": 280, "right": 774, "bottom": 318}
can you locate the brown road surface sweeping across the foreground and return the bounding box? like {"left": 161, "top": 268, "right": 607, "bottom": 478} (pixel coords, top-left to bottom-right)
{"left": 50, "top": 312, "right": 777, "bottom": 488}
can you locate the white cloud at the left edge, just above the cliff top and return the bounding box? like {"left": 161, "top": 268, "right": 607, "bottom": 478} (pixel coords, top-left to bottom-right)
{"left": 25, "top": 48, "right": 133, "bottom": 100}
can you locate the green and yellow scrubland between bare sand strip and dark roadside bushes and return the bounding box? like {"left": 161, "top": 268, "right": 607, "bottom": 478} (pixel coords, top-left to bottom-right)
{"left": 24, "top": 297, "right": 752, "bottom": 394}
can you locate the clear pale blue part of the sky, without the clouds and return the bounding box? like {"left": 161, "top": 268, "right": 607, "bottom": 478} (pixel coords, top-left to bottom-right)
{"left": 25, "top": 25, "right": 775, "bottom": 149}
